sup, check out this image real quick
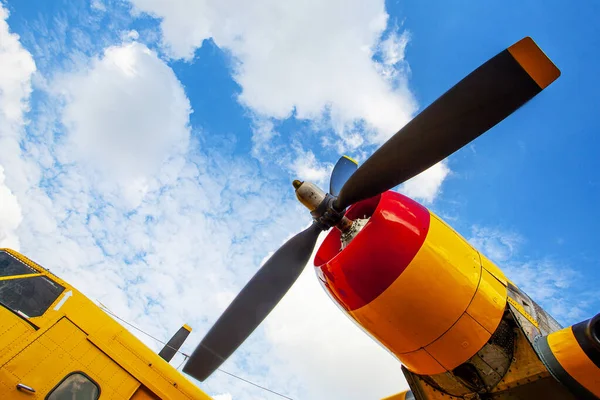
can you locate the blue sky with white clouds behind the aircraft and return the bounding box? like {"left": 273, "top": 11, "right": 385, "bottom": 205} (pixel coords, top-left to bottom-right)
{"left": 0, "top": 0, "right": 600, "bottom": 400}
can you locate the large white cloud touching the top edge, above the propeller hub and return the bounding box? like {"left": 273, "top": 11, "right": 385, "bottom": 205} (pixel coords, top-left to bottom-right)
{"left": 126, "top": 0, "right": 416, "bottom": 143}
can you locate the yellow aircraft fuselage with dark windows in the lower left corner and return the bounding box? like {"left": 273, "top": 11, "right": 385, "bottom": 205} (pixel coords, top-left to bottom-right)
{"left": 0, "top": 249, "right": 210, "bottom": 400}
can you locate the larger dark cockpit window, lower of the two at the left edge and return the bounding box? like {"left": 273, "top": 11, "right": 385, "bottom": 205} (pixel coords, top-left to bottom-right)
{"left": 0, "top": 276, "right": 65, "bottom": 317}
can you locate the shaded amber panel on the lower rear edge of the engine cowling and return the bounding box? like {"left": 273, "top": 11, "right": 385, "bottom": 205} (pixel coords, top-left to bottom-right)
{"left": 425, "top": 314, "right": 492, "bottom": 370}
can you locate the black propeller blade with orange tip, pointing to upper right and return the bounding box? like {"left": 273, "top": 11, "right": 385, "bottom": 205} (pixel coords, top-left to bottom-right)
{"left": 334, "top": 37, "right": 560, "bottom": 211}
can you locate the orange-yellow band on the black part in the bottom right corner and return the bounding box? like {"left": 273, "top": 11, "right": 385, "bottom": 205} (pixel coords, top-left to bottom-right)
{"left": 548, "top": 327, "right": 600, "bottom": 397}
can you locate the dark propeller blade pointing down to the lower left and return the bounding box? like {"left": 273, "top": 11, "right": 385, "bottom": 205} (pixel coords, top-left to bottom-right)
{"left": 183, "top": 224, "right": 321, "bottom": 381}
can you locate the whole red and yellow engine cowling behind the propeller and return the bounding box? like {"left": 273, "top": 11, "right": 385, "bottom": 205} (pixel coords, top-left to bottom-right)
{"left": 315, "top": 192, "right": 507, "bottom": 374}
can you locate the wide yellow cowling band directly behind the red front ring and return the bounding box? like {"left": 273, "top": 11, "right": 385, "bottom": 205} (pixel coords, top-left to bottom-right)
{"left": 350, "top": 214, "right": 481, "bottom": 355}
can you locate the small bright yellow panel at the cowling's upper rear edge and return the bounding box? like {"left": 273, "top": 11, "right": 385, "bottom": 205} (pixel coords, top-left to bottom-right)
{"left": 467, "top": 269, "right": 507, "bottom": 334}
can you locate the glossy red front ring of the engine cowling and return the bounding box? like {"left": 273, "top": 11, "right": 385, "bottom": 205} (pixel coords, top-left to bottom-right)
{"left": 315, "top": 192, "right": 430, "bottom": 311}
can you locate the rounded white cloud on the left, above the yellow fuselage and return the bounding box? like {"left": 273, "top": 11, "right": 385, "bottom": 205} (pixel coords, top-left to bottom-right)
{"left": 56, "top": 42, "right": 191, "bottom": 180}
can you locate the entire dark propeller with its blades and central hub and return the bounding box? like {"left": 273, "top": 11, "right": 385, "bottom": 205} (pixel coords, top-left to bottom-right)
{"left": 183, "top": 37, "right": 560, "bottom": 381}
